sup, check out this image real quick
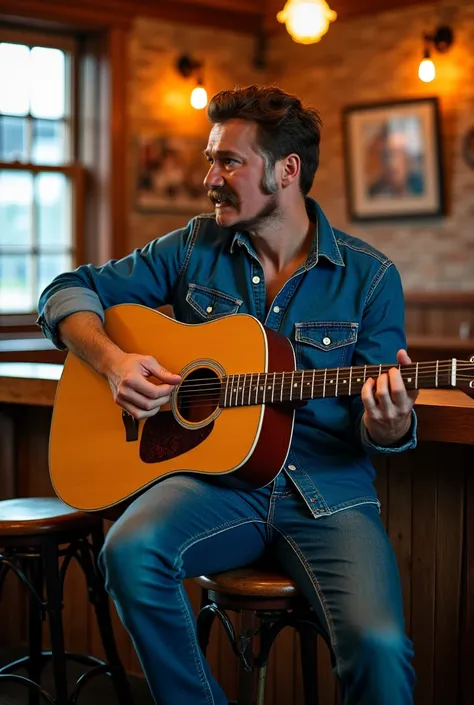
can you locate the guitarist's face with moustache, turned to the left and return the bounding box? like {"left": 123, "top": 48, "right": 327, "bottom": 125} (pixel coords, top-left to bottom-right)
{"left": 204, "top": 119, "right": 278, "bottom": 230}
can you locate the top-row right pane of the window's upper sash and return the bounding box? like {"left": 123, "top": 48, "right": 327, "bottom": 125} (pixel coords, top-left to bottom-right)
{"left": 30, "top": 47, "right": 66, "bottom": 118}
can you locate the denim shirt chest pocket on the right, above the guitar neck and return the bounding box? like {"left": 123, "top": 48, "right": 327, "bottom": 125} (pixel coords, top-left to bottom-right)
{"left": 295, "top": 321, "right": 359, "bottom": 369}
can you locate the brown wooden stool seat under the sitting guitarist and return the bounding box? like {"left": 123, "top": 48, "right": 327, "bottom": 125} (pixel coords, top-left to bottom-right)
{"left": 195, "top": 566, "right": 300, "bottom": 598}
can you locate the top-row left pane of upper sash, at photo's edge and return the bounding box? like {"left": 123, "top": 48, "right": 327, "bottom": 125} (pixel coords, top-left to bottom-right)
{"left": 0, "top": 42, "right": 30, "bottom": 115}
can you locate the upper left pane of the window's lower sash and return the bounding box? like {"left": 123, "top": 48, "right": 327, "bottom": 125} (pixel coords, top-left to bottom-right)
{"left": 0, "top": 170, "right": 33, "bottom": 248}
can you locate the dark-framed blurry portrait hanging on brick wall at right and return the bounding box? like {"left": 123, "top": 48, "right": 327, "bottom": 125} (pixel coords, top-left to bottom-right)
{"left": 344, "top": 98, "right": 444, "bottom": 221}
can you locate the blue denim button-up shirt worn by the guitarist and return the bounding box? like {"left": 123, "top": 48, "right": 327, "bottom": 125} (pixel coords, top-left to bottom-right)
{"left": 38, "top": 198, "right": 416, "bottom": 517}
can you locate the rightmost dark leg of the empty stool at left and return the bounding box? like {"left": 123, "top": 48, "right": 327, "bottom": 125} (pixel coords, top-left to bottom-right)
{"left": 81, "top": 528, "right": 133, "bottom": 705}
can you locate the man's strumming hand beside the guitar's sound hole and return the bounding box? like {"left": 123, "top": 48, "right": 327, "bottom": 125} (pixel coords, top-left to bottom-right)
{"left": 106, "top": 353, "right": 182, "bottom": 419}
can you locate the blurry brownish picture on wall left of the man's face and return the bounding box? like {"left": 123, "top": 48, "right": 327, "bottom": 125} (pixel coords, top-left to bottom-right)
{"left": 135, "top": 136, "right": 211, "bottom": 213}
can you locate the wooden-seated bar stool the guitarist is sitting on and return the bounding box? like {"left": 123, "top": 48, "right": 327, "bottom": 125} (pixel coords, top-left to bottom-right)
{"left": 195, "top": 566, "right": 332, "bottom": 705}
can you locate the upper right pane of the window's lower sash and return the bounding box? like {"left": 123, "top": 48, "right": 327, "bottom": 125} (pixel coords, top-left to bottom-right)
{"left": 35, "top": 174, "right": 72, "bottom": 250}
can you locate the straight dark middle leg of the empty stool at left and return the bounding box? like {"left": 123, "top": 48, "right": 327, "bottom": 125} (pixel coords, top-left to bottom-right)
{"left": 42, "top": 535, "right": 68, "bottom": 705}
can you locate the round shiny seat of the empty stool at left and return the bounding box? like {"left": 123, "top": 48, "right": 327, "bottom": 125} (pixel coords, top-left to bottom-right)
{"left": 0, "top": 497, "right": 101, "bottom": 537}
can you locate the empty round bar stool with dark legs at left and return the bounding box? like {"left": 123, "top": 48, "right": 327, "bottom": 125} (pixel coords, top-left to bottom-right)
{"left": 0, "top": 497, "right": 132, "bottom": 705}
